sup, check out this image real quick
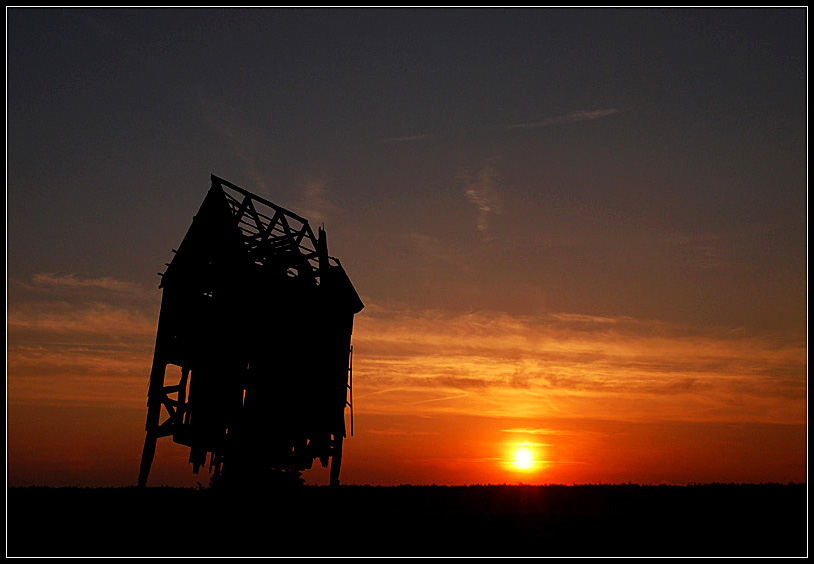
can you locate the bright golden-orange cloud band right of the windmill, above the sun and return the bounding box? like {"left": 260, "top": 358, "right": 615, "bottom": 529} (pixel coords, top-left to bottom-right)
{"left": 353, "top": 308, "right": 806, "bottom": 423}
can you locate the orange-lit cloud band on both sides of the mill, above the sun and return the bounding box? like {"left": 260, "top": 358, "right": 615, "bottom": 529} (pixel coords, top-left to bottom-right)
{"left": 6, "top": 268, "right": 807, "bottom": 424}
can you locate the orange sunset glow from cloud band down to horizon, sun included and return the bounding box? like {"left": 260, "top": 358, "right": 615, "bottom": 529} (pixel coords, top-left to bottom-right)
{"left": 7, "top": 277, "right": 807, "bottom": 485}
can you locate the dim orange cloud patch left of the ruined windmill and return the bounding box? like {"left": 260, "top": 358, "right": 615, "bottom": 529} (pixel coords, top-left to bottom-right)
{"left": 6, "top": 273, "right": 160, "bottom": 407}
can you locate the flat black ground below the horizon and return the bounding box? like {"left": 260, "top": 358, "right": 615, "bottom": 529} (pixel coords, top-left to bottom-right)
{"left": 6, "top": 484, "right": 808, "bottom": 556}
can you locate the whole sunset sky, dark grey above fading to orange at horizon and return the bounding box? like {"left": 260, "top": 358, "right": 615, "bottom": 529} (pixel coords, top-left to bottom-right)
{"left": 6, "top": 8, "right": 808, "bottom": 486}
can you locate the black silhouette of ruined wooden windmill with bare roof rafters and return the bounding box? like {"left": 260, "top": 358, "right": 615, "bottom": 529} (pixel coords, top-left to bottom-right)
{"left": 138, "top": 175, "right": 364, "bottom": 486}
